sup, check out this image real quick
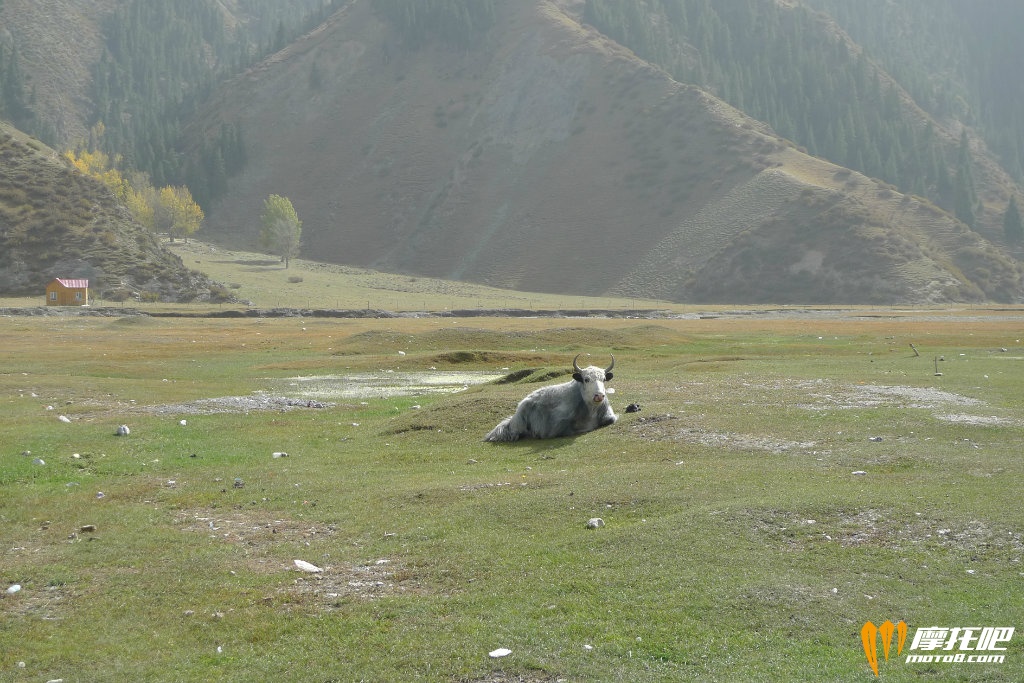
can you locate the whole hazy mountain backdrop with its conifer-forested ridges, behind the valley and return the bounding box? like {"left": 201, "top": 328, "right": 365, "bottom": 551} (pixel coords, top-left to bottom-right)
{"left": 0, "top": 0, "right": 1024, "bottom": 303}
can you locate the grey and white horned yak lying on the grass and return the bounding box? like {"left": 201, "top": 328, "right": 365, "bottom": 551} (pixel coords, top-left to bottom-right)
{"left": 483, "top": 353, "right": 618, "bottom": 441}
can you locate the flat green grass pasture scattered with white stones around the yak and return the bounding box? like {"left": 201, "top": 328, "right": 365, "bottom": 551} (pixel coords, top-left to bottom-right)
{"left": 0, "top": 311, "right": 1024, "bottom": 681}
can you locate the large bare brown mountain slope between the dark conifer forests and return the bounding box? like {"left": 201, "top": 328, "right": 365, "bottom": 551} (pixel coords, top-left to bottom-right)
{"left": 191, "top": 0, "right": 1022, "bottom": 303}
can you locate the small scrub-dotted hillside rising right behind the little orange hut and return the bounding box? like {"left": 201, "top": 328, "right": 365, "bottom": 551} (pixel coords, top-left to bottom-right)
{"left": 0, "top": 123, "right": 222, "bottom": 301}
